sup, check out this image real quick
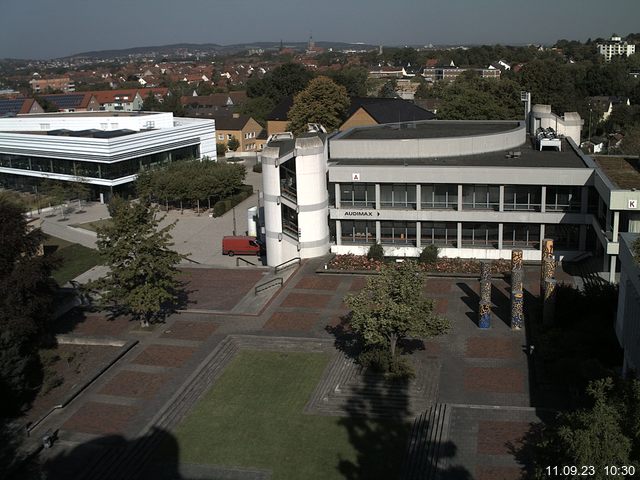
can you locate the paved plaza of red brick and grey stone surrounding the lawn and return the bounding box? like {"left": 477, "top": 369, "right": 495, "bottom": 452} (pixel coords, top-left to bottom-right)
{"left": 34, "top": 259, "right": 569, "bottom": 480}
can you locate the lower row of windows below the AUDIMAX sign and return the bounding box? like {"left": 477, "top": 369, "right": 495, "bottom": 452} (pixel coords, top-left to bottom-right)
{"left": 340, "top": 220, "right": 579, "bottom": 250}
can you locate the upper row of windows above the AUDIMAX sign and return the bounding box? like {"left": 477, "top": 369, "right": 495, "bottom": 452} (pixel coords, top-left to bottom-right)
{"left": 338, "top": 183, "right": 582, "bottom": 212}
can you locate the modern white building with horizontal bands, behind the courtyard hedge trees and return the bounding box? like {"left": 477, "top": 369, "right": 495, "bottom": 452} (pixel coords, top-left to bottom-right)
{"left": 0, "top": 112, "right": 216, "bottom": 199}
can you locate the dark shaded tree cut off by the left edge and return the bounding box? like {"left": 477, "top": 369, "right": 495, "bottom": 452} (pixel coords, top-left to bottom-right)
{"left": 0, "top": 194, "right": 57, "bottom": 417}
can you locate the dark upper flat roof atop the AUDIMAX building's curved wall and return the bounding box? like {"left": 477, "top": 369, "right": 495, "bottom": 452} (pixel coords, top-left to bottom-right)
{"left": 335, "top": 120, "right": 521, "bottom": 140}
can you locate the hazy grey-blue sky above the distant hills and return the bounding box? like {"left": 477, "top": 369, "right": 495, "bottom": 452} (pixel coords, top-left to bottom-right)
{"left": 0, "top": 0, "right": 640, "bottom": 58}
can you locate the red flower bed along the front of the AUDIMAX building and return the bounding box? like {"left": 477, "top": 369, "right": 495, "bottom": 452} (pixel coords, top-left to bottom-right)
{"left": 327, "top": 254, "right": 511, "bottom": 275}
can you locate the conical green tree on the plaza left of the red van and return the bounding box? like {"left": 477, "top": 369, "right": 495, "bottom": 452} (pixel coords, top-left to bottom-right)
{"left": 89, "top": 197, "right": 186, "bottom": 326}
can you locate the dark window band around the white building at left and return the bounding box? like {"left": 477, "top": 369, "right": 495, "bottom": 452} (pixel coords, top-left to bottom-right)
{"left": 0, "top": 145, "right": 200, "bottom": 180}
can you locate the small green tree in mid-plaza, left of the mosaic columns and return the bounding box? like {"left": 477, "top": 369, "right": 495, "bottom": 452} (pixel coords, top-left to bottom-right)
{"left": 345, "top": 261, "right": 449, "bottom": 363}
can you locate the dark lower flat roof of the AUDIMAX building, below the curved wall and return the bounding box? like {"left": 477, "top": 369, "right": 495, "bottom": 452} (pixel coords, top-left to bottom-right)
{"left": 329, "top": 139, "right": 589, "bottom": 168}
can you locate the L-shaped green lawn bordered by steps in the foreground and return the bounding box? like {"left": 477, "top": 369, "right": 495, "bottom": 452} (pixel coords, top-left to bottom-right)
{"left": 175, "top": 351, "right": 408, "bottom": 480}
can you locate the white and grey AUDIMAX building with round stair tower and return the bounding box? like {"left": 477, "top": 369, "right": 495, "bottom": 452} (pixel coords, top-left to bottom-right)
{"left": 262, "top": 105, "right": 640, "bottom": 281}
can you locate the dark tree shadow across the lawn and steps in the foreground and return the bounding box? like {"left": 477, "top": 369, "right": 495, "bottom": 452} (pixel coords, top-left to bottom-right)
{"left": 337, "top": 354, "right": 471, "bottom": 480}
